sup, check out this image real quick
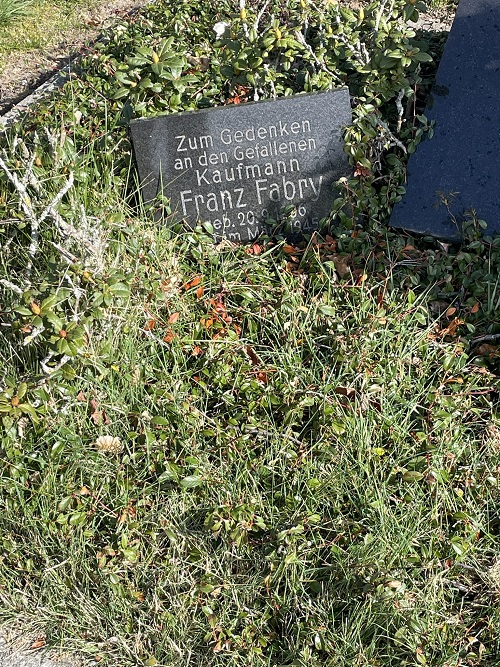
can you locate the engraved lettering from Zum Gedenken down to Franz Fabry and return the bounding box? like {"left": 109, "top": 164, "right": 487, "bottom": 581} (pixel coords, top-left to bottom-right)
{"left": 174, "top": 120, "right": 323, "bottom": 217}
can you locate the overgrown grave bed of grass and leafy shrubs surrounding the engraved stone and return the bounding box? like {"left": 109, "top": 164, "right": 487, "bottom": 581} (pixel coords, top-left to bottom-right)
{"left": 0, "top": 0, "right": 500, "bottom": 667}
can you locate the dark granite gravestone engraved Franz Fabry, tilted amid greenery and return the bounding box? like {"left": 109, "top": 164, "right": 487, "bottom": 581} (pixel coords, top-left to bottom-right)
{"left": 130, "top": 88, "right": 351, "bottom": 241}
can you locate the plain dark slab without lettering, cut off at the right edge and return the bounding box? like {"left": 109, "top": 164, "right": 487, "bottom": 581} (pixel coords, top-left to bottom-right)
{"left": 390, "top": 0, "right": 500, "bottom": 240}
